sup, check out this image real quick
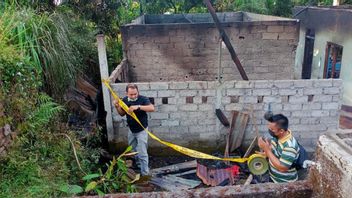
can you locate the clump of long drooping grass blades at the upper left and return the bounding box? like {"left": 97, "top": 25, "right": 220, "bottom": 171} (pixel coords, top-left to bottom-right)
{"left": 0, "top": 7, "right": 81, "bottom": 98}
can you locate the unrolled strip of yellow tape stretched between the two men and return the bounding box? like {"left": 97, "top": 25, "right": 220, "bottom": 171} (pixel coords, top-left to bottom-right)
{"left": 103, "top": 80, "right": 249, "bottom": 163}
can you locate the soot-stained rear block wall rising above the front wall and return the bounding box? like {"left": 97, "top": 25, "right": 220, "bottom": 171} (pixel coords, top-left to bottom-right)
{"left": 121, "top": 15, "right": 299, "bottom": 82}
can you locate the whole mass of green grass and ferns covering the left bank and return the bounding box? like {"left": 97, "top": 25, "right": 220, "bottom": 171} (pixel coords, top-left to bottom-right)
{"left": 0, "top": 1, "right": 100, "bottom": 197}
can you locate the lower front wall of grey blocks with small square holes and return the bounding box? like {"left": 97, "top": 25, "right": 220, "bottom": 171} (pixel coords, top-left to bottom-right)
{"left": 112, "top": 79, "right": 342, "bottom": 151}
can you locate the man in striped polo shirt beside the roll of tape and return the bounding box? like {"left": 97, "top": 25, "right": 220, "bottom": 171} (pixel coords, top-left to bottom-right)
{"left": 258, "top": 114, "right": 300, "bottom": 183}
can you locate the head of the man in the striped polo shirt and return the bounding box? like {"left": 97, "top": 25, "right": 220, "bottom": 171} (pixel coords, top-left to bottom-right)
{"left": 268, "top": 114, "right": 288, "bottom": 137}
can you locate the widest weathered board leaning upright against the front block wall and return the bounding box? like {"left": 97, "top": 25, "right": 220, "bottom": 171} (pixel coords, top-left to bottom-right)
{"left": 229, "top": 112, "right": 249, "bottom": 152}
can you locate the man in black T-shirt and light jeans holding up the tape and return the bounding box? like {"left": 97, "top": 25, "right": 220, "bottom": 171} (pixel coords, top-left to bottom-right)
{"left": 114, "top": 84, "right": 154, "bottom": 176}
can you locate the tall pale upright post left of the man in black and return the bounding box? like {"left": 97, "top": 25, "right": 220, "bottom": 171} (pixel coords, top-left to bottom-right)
{"left": 97, "top": 34, "right": 114, "bottom": 143}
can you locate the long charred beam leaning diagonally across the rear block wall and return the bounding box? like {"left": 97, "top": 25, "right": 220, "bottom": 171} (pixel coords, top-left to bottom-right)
{"left": 203, "top": 0, "right": 248, "bottom": 80}
